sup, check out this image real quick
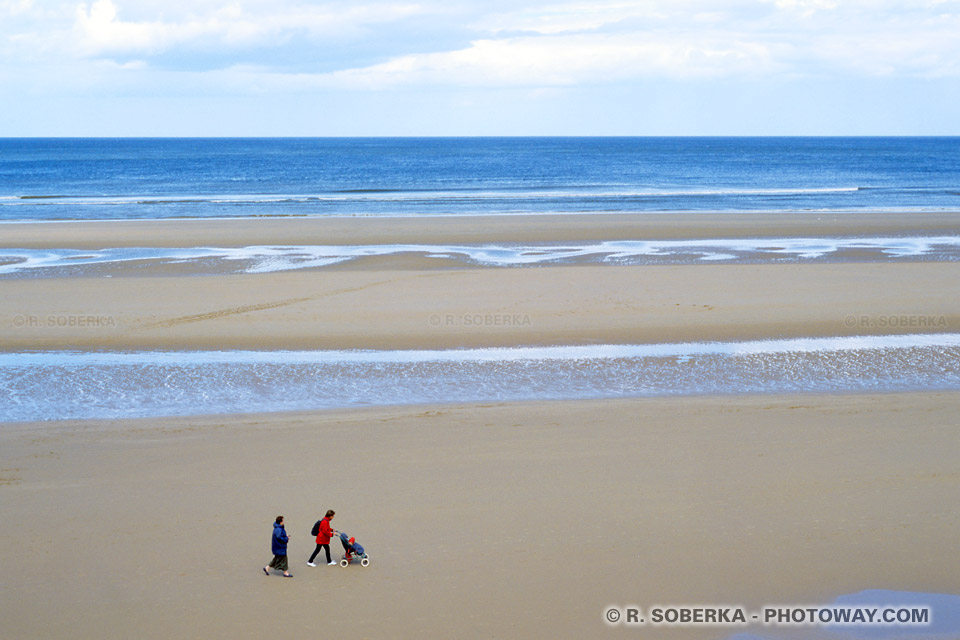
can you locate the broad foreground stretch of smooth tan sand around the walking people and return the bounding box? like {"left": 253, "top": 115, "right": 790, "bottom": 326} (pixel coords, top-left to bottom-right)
{"left": 0, "top": 393, "right": 960, "bottom": 638}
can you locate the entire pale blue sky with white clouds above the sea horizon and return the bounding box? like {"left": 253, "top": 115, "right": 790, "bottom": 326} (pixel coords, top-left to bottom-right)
{"left": 0, "top": 0, "right": 960, "bottom": 136}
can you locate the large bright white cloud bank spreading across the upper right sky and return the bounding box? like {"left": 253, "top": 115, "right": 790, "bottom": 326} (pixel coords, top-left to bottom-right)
{"left": 260, "top": 0, "right": 960, "bottom": 89}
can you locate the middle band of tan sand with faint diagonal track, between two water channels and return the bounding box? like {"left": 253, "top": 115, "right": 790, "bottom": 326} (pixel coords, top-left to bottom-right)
{"left": 0, "top": 263, "right": 960, "bottom": 351}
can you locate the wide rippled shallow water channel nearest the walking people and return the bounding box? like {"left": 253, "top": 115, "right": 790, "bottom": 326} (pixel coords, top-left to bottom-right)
{"left": 0, "top": 334, "right": 960, "bottom": 421}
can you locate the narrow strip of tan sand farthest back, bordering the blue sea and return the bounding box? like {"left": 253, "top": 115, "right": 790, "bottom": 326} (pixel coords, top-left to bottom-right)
{"left": 0, "top": 212, "right": 960, "bottom": 249}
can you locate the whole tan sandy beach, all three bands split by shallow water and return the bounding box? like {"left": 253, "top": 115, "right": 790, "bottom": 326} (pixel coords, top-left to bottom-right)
{"left": 0, "top": 213, "right": 960, "bottom": 639}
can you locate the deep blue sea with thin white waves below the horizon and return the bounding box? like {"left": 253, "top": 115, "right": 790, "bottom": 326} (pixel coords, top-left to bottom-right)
{"left": 0, "top": 138, "right": 960, "bottom": 221}
